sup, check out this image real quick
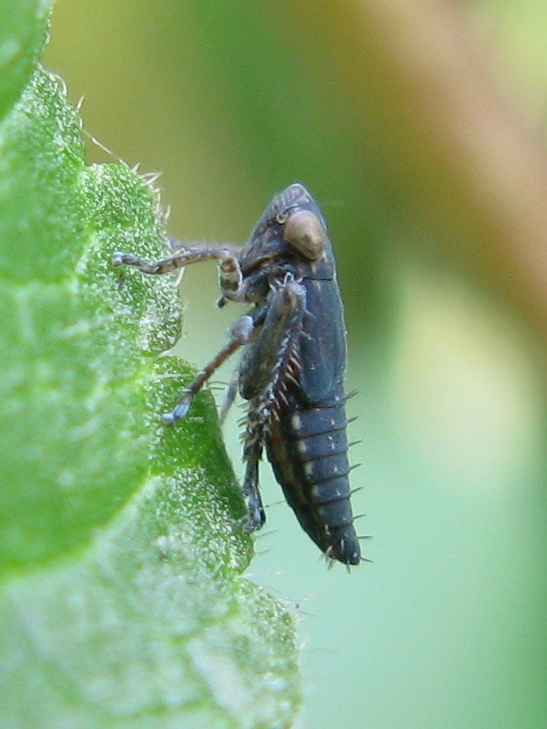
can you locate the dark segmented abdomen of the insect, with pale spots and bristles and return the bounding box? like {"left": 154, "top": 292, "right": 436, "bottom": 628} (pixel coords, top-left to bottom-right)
{"left": 266, "top": 392, "right": 361, "bottom": 565}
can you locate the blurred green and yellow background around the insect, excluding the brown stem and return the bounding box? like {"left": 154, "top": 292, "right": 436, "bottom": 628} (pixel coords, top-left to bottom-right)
{"left": 45, "top": 0, "right": 547, "bottom": 729}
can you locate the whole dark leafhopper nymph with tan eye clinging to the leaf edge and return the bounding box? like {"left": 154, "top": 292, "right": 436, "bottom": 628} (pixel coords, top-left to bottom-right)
{"left": 114, "top": 183, "right": 363, "bottom": 566}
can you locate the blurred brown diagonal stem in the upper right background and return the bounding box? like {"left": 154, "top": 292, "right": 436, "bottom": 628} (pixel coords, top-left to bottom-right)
{"left": 280, "top": 0, "right": 547, "bottom": 343}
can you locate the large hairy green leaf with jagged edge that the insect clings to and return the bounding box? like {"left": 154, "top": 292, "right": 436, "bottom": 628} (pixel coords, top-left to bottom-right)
{"left": 0, "top": 3, "right": 300, "bottom": 729}
